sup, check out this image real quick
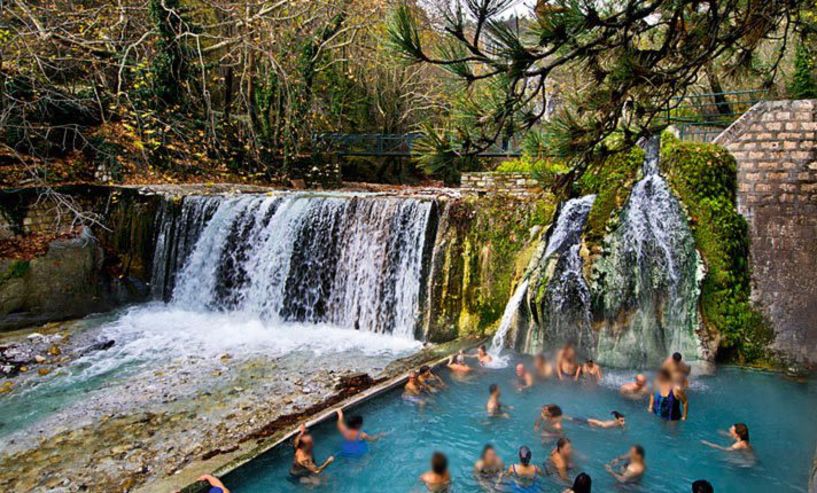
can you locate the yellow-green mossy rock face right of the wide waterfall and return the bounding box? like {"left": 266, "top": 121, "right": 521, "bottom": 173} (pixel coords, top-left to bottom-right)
{"left": 423, "top": 194, "right": 555, "bottom": 342}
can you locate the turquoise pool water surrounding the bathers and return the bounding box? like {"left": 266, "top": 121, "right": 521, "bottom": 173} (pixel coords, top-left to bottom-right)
{"left": 225, "top": 356, "right": 817, "bottom": 493}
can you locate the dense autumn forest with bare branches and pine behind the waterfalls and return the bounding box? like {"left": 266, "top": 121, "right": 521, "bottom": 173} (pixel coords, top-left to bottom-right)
{"left": 0, "top": 0, "right": 817, "bottom": 186}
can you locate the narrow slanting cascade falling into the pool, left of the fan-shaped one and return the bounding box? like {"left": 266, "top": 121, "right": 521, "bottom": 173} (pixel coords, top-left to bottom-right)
{"left": 492, "top": 195, "right": 595, "bottom": 353}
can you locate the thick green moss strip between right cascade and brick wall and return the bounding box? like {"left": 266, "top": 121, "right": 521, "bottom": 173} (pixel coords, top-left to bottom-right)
{"left": 661, "top": 139, "right": 774, "bottom": 364}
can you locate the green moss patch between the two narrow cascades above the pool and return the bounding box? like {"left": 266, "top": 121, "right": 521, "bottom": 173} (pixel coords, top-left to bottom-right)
{"left": 577, "top": 147, "right": 644, "bottom": 249}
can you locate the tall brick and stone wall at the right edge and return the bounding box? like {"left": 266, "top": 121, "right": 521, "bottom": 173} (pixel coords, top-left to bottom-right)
{"left": 715, "top": 100, "right": 817, "bottom": 365}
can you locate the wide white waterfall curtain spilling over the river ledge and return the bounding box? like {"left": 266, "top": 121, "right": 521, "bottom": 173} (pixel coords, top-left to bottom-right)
{"left": 154, "top": 193, "right": 432, "bottom": 338}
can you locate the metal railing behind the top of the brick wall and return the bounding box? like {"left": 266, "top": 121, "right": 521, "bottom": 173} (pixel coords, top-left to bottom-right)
{"left": 666, "top": 89, "right": 768, "bottom": 142}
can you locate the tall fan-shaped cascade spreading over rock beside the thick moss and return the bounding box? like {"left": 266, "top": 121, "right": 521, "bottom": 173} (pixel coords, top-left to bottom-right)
{"left": 592, "top": 137, "right": 701, "bottom": 367}
